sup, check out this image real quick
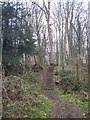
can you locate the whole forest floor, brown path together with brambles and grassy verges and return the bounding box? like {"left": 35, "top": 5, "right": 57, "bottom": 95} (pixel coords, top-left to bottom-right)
{"left": 2, "top": 68, "right": 88, "bottom": 118}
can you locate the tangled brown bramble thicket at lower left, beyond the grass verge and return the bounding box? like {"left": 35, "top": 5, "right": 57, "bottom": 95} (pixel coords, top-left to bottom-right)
{"left": 3, "top": 76, "right": 35, "bottom": 118}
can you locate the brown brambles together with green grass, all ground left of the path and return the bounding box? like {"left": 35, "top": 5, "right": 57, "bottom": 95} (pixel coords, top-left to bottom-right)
{"left": 2, "top": 73, "right": 52, "bottom": 118}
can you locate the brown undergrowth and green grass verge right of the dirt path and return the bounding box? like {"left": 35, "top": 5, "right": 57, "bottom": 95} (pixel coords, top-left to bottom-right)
{"left": 55, "top": 71, "right": 89, "bottom": 117}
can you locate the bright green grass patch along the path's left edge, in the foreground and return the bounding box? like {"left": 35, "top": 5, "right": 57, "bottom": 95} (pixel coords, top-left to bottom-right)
{"left": 31, "top": 95, "right": 52, "bottom": 118}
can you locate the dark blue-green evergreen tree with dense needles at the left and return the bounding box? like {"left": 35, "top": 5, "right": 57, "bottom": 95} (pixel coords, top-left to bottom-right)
{"left": 2, "top": 1, "right": 35, "bottom": 74}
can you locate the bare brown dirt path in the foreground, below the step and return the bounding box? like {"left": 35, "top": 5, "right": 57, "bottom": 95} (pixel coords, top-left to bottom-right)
{"left": 41, "top": 67, "right": 85, "bottom": 118}
